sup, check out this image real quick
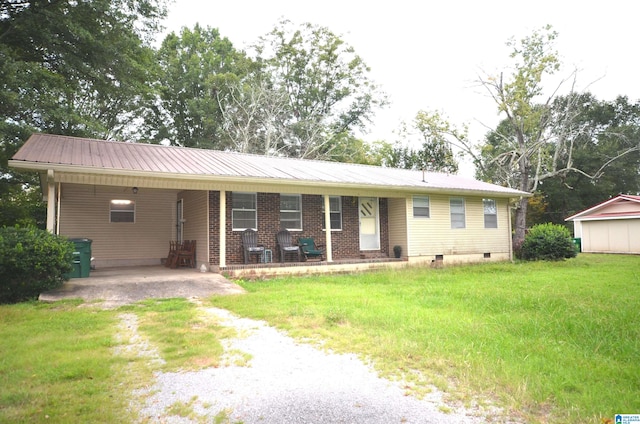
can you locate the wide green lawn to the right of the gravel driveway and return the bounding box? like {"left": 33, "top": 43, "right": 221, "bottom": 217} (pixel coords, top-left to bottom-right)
{"left": 212, "top": 254, "right": 640, "bottom": 423}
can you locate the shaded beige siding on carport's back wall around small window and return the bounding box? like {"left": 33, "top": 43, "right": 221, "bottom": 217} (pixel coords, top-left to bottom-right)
{"left": 60, "top": 184, "right": 176, "bottom": 267}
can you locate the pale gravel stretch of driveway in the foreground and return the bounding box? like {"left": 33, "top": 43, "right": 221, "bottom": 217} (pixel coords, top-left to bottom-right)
{"left": 134, "top": 308, "right": 496, "bottom": 424}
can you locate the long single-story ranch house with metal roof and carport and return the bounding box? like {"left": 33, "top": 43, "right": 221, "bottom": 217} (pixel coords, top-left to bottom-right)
{"left": 9, "top": 134, "right": 529, "bottom": 271}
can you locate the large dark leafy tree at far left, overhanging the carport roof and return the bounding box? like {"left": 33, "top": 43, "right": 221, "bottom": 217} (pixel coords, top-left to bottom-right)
{"left": 0, "top": 0, "right": 166, "bottom": 229}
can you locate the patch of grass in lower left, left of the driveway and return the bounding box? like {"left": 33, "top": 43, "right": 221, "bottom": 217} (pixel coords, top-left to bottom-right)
{"left": 0, "top": 302, "right": 131, "bottom": 423}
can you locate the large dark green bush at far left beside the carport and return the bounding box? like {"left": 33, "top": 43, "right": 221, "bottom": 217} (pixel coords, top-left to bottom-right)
{"left": 0, "top": 227, "right": 74, "bottom": 303}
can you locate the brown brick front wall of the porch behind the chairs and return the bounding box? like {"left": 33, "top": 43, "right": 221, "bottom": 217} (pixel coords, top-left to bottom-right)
{"left": 209, "top": 191, "right": 389, "bottom": 265}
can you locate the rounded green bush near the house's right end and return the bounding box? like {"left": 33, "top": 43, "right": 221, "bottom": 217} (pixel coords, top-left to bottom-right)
{"left": 520, "top": 223, "right": 578, "bottom": 261}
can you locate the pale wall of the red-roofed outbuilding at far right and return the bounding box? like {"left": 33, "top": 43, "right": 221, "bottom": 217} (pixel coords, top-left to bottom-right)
{"left": 582, "top": 219, "right": 640, "bottom": 253}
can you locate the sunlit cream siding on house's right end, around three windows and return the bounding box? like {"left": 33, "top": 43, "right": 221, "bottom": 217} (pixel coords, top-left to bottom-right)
{"left": 407, "top": 195, "right": 510, "bottom": 260}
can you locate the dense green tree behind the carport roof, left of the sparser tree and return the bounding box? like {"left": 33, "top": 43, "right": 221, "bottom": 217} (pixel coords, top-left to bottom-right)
{"left": 145, "top": 24, "right": 250, "bottom": 149}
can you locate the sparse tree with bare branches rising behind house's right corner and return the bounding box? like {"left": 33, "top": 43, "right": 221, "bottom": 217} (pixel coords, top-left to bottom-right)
{"left": 477, "top": 26, "right": 571, "bottom": 245}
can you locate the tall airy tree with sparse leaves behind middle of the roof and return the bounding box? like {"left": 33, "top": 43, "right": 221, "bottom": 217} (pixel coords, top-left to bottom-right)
{"left": 254, "top": 20, "right": 386, "bottom": 158}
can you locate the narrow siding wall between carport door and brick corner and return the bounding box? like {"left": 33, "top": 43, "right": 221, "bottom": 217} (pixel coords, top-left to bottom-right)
{"left": 178, "top": 191, "right": 209, "bottom": 266}
